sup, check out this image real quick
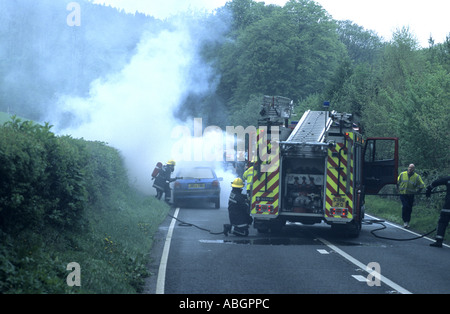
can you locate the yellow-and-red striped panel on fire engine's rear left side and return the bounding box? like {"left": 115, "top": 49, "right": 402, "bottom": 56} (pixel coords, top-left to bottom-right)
{"left": 251, "top": 129, "right": 280, "bottom": 216}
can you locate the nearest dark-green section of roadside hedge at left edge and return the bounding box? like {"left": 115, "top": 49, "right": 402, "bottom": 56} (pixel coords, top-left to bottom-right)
{"left": 0, "top": 118, "right": 87, "bottom": 232}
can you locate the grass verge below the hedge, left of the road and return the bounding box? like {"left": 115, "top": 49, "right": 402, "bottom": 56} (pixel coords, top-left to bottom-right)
{"left": 0, "top": 194, "right": 169, "bottom": 294}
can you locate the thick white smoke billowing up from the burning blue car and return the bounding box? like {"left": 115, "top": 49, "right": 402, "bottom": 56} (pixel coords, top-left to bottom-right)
{"left": 49, "top": 17, "right": 229, "bottom": 191}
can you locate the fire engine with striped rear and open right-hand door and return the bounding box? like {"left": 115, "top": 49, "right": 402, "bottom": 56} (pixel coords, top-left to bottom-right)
{"left": 250, "top": 96, "right": 398, "bottom": 237}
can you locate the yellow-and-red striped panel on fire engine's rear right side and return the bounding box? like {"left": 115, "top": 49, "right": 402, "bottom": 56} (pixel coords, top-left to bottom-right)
{"left": 325, "top": 133, "right": 353, "bottom": 220}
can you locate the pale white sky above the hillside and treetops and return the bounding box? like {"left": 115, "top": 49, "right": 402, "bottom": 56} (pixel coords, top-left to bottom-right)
{"left": 94, "top": 0, "right": 450, "bottom": 47}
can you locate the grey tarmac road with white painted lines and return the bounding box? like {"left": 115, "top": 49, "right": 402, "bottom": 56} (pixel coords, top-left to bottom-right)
{"left": 146, "top": 204, "right": 450, "bottom": 295}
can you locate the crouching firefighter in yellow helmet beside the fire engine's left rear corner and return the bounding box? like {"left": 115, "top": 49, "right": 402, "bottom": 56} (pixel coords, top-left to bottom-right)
{"left": 223, "top": 178, "right": 253, "bottom": 236}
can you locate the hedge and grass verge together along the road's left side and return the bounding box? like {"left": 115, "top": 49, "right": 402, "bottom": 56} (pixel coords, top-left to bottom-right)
{"left": 0, "top": 117, "right": 168, "bottom": 293}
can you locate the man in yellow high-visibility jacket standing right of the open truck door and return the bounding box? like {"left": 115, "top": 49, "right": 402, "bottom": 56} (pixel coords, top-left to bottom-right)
{"left": 397, "top": 164, "right": 425, "bottom": 228}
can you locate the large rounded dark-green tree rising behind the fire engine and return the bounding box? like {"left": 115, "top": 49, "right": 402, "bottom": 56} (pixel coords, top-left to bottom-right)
{"left": 214, "top": 0, "right": 344, "bottom": 110}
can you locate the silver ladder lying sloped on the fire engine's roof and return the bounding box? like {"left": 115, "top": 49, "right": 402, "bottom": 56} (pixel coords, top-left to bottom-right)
{"left": 283, "top": 110, "right": 334, "bottom": 144}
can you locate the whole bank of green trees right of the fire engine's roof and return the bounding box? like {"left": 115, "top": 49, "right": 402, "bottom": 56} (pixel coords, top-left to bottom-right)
{"left": 324, "top": 28, "right": 450, "bottom": 171}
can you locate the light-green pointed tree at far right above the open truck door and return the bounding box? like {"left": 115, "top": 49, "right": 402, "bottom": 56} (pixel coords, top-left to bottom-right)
{"left": 362, "top": 28, "right": 450, "bottom": 169}
